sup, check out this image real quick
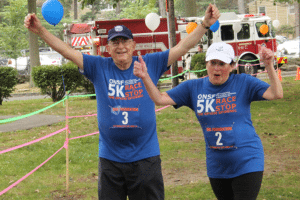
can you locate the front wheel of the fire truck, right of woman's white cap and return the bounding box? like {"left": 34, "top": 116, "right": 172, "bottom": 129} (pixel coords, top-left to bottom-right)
{"left": 239, "top": 56, "right": 259, "bottom": 77}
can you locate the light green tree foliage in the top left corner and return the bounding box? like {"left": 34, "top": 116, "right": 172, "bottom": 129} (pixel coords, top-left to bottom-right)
{"left": 0, "top": 0, "right": 28, "bottom": 66}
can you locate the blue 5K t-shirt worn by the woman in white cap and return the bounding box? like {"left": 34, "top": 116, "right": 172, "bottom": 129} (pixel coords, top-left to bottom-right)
{"left": 167, "top": 74, "right": 269, "bottom": 178}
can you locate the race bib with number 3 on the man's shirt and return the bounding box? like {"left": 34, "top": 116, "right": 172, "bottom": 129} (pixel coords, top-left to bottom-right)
{"left": 110, "top": 106, "right": 140, "bottom": 128}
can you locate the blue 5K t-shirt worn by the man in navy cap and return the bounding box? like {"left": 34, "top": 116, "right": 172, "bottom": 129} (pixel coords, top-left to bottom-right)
{"left": 83, "top": 50, "right": 169, "bottom": 163}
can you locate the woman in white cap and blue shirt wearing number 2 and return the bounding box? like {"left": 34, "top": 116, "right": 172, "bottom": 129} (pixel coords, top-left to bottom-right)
{"left": 134, "top": 43, "right": 283, "bottom": 200}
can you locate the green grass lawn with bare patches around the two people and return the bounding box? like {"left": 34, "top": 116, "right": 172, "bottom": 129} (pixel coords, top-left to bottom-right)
{"left": 0, "top": 78, "right": 300, "bottom": 200}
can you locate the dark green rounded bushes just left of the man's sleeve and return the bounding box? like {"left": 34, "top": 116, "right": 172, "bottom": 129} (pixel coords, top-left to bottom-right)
{"left": 32, "top": 62, "right": 83, "bottom": 102}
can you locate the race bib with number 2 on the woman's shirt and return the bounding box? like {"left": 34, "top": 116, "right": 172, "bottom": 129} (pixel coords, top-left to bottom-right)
{"left": 204, "top": 126, "right": 237, "bottom": 150}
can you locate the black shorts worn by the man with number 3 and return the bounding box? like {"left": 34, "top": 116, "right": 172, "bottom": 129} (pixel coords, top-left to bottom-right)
{"left": 98, "top": 156, "right": 164, "bottom": 200}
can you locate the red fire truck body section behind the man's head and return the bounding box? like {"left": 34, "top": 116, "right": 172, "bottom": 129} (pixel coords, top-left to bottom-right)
{"left": 64, "top": 18, "right": 183, "bottom": 76}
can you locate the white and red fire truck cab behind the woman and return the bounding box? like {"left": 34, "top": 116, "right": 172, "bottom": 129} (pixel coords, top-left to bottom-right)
{"left": 180, "top": 12, "right": 287, "bottom": 74}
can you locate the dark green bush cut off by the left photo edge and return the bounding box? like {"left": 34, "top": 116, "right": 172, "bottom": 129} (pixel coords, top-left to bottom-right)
{"left": 0, "top": 67, "right": 18, "bottom": 105}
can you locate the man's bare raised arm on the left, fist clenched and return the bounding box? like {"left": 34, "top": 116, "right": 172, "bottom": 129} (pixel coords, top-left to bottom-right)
{"left": 24, "top": 14, "right": 83, "bottom": 69}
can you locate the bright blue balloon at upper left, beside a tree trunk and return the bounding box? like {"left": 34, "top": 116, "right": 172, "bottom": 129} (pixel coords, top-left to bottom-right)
{"left": 42, "top": 0, "right": 64, "bottom": 26}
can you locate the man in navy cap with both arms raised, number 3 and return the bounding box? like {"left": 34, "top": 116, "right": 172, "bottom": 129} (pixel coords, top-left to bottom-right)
{"left": 24, "top": 5, "right": 220, "bottom": 200}
